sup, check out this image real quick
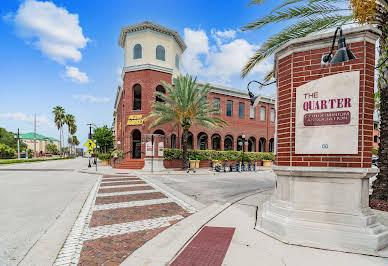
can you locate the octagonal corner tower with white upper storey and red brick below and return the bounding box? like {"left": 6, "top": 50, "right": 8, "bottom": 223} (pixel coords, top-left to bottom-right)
{"left": 115, "top": 22, "right": 186, "bottom": 161}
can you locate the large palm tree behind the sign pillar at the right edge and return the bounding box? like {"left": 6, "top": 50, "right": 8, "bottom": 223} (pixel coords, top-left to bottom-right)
{"left": 241, "top": 0, "right": 388, "bottom": 201}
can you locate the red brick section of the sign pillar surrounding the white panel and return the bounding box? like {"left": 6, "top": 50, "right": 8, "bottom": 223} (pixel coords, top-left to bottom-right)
{"left": 275, "top": 41, "right": 375, "bottom": 167}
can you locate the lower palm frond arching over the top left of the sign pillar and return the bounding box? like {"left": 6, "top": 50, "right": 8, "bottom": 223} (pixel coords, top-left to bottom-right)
{"left": 241, "top": 15, "right": 353, "bottom": 78}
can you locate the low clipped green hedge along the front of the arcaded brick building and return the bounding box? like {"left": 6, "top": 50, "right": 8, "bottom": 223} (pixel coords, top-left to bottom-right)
{"left": 163, "top": 148, "right": 275, "bottom": 161}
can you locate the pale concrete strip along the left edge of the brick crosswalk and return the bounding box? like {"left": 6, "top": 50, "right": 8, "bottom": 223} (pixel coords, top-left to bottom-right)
{"left": 18, "top": 181, "right": 98, "bottom": 266}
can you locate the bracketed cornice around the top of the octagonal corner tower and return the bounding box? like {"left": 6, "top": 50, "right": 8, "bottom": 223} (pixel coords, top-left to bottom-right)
{"left": 119, "top": 21, "right": 187, "bottom": 53}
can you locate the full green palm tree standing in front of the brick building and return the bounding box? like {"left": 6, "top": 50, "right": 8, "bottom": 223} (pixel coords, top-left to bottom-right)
{"left": 146, "top": 75, "right": 226, "bottom": 168}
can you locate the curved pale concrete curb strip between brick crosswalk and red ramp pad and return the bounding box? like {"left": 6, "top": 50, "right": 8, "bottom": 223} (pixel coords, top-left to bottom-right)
{"left": 120, "top": 203, "right": 232, "bottom": 266}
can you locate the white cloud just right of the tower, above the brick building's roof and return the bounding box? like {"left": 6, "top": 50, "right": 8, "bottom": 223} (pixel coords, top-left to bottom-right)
{"left": 182, "top": 28, "right": 273, "bottom": 84}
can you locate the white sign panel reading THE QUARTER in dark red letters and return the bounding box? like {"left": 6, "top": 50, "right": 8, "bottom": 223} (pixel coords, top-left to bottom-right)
{"left": 295, "top": 71, "right": 360, "bottom": 154}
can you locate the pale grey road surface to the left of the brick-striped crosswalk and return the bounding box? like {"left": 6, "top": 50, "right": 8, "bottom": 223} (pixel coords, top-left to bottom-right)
{"left": 0, "top": 158, "right": 98, "bottom": 265}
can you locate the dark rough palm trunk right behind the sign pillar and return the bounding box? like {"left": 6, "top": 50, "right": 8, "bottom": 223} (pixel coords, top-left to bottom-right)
{"left": 372, "top": 26, "right": 388, "bottom": 201}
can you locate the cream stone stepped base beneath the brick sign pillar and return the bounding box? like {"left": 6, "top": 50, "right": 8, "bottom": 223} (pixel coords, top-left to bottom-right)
{"left": 256, "top": 166, "right": 388, "bottom": 257}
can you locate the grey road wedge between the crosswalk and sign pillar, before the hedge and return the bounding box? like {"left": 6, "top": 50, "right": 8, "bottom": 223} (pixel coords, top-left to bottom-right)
{"left": 147, "top": 170, "right": 275, "bottom": 205}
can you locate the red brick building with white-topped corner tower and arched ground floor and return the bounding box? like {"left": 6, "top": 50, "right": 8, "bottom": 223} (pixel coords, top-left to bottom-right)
{"left": 113, "top": 22, "right": 275, "bottom": 159}
